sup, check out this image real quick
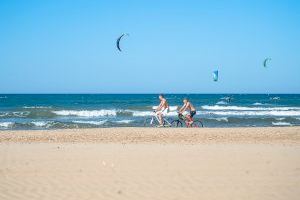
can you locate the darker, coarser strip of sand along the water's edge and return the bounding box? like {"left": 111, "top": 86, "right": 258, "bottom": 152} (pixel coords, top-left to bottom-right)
{"left": 0, "top": 127, "right": 300, "bottom": 144}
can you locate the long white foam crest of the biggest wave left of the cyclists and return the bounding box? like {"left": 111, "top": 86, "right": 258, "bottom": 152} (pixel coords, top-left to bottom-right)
{"left": 52, "top": 110, "right": 117, "bottom": 117}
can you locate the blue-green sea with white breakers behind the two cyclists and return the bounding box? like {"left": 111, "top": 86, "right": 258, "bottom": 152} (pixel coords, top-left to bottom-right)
{"left": 0, "top": 94, "right": 300, "bottom": 130}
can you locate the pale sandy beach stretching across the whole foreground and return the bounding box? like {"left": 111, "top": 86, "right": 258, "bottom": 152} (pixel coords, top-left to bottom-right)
{"left": 0, "top": 127, "right": 300, "bottom": 200}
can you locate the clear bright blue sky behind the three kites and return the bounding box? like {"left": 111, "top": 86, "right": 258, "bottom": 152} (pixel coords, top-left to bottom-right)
{"left": 0, "top": 0, "right": 300, "bottom": 93}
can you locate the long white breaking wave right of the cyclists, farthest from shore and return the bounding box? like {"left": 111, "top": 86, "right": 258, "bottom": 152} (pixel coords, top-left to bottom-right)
{"left": 201, "top": 105, "right": 300, "bottom": 111}
